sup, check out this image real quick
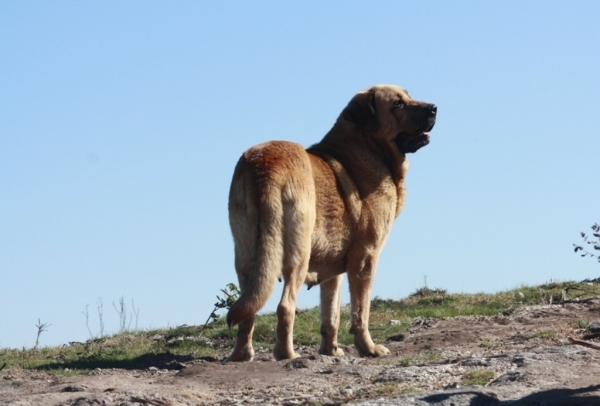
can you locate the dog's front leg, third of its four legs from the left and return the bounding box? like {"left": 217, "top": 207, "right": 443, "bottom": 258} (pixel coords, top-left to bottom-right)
{"left": 319, "top": 275, "right": 344, "bottom": 356}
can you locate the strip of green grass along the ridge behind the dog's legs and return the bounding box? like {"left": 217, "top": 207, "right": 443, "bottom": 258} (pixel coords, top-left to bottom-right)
{"left": 0, "top": 282, "right": 600, "bottom": 374}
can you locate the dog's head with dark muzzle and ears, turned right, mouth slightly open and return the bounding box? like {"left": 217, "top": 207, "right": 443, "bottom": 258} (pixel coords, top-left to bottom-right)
{"left": 340, "top": 85, "right": 437, "bottom": 154}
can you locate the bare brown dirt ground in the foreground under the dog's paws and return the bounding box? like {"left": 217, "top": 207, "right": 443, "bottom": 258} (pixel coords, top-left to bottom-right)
{"left": 0, "top": 303, "right": 600, "bottom": 406}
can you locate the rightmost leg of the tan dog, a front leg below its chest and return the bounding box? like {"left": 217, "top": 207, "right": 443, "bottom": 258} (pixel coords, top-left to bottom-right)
{"left": 348, "top": 252, "right": 390, "bottom": 357}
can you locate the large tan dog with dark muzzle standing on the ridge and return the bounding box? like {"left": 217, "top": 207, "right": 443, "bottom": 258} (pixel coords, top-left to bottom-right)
{"left": 227, "top": 85, "right": 437, "bottom": 361}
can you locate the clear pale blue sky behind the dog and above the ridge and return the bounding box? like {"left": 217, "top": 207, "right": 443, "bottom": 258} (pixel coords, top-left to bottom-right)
{"left": 0, "top": 0, "right": 600, "bottom": 348}
